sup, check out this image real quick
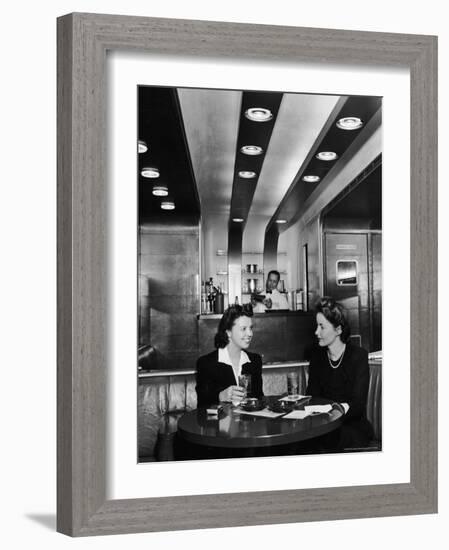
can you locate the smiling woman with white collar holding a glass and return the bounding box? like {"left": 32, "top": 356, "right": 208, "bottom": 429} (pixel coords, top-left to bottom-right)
{"left": 196, "top": 305, "right": 263, "bottom": 407}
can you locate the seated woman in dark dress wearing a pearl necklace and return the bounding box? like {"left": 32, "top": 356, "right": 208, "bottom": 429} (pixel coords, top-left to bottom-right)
{"left": 307, "top": 297, "right": 373, "bottom": 450}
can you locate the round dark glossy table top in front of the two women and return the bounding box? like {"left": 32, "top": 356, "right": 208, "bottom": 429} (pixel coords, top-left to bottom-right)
{"left": 178, "top": 396, "right": 343, "bottom": 448}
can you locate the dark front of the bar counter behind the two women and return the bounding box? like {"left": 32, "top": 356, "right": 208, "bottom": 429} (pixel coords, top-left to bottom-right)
{"left": 197, "top": 310, "right": 315, "bottom": 363}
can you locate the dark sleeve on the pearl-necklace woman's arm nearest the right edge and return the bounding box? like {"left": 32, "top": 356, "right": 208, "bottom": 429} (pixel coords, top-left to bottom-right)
{"left": 346, "top": 347, "right": 369, "bottom": 420}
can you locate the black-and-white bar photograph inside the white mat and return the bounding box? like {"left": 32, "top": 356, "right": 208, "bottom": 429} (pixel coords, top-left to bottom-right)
{"left": 136, "top": 85, "right": 382, "bottom": 462}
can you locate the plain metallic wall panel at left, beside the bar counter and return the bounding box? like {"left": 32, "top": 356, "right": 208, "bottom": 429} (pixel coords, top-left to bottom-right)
{"left": 139, "top": 220, "right": 199, "bottom": 369}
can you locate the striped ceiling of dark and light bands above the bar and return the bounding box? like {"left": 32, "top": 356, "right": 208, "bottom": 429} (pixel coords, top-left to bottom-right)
{"left": 139, "top": 87, "right": 381, "bottom": 270}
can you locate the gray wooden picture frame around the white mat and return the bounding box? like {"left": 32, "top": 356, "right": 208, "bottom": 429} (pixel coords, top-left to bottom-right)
{"left": 57, "top": 13, "right": 437, "bottom": 536}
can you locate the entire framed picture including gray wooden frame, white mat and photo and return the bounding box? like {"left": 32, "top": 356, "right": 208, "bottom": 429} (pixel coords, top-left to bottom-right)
{"left": 58, "top": 14, "right": 437, "bottom": 536}
